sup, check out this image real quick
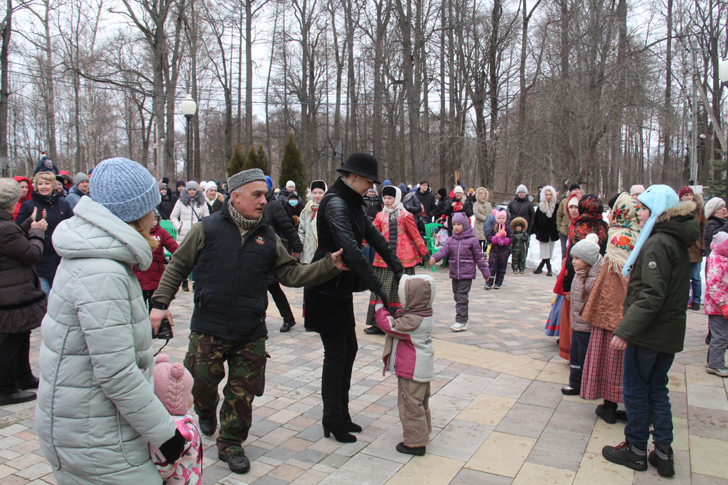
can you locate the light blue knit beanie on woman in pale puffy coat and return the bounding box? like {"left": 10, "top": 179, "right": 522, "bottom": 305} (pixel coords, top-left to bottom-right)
{"left": 89, "top": 158, "right": 162, "bottom": 222}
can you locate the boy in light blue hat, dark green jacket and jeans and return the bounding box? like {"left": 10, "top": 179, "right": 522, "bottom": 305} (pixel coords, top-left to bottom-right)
{"left": 602, "top": 185, "right": 700, "bottom": 477}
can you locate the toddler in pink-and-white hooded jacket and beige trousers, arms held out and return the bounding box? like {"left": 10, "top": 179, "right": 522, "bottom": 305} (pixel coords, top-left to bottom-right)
{"left": 374, "top": 275, "right": 435, "bottom": 456}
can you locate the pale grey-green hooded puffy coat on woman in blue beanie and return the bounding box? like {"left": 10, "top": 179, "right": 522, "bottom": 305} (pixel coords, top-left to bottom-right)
{"left": 35, "top": 197, "right": 176, "bottom": 485}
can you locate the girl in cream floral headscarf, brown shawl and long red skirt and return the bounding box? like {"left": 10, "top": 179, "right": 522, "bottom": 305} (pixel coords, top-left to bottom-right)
{"left": 581, "top": 192, "right": 640, "bottom": 424}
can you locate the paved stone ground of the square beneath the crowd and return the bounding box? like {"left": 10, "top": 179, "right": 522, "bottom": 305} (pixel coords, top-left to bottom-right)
{"left": 0, "top": 268, "right": 728, "bottom": 485}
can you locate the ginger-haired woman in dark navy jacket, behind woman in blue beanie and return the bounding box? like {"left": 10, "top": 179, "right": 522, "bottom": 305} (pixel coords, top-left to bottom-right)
{"left": 15, "top": 172, "right": 73, "bottom": 296}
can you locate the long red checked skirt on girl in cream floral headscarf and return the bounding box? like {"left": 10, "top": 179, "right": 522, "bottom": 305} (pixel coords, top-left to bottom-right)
{"left": 581, "top": 327, "right": 624, "bottom": 402}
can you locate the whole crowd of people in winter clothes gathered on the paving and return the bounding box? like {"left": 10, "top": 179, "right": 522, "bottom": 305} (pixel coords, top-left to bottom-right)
{"left": 0, "top": 153, "right": 728, "bottom": 484}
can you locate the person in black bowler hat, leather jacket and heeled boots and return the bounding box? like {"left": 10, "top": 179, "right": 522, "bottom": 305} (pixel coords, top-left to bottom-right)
{"left": 303, "top": 153, "right": 404, "bottom": 443}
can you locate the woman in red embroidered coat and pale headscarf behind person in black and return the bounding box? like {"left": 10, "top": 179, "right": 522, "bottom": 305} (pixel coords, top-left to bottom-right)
{"left": 364, "top": 185, "right": 429, "bottom": 334}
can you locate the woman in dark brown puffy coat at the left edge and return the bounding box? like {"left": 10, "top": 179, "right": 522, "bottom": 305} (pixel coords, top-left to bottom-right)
{"left": 0, "top": 178, "right": 50, "bottom": 406}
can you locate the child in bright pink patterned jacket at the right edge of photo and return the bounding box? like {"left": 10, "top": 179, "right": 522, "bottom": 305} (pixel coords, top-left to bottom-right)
{"left": 705, "top": 232, "right": 728, "bottom": 377}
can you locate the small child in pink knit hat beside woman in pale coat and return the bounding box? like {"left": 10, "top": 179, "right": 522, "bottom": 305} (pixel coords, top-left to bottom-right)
{"left": 150, "top": 354, "right": 202, "bottom": 485}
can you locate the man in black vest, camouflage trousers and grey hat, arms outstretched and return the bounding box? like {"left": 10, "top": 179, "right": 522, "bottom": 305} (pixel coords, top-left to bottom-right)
{"left": 150, "top": 169, "right": 346, "bottom": 473}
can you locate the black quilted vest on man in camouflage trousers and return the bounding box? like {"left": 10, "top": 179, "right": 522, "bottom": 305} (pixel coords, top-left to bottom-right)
{"left": 190, "top": 200, "right": 276, "bottom": 340}
